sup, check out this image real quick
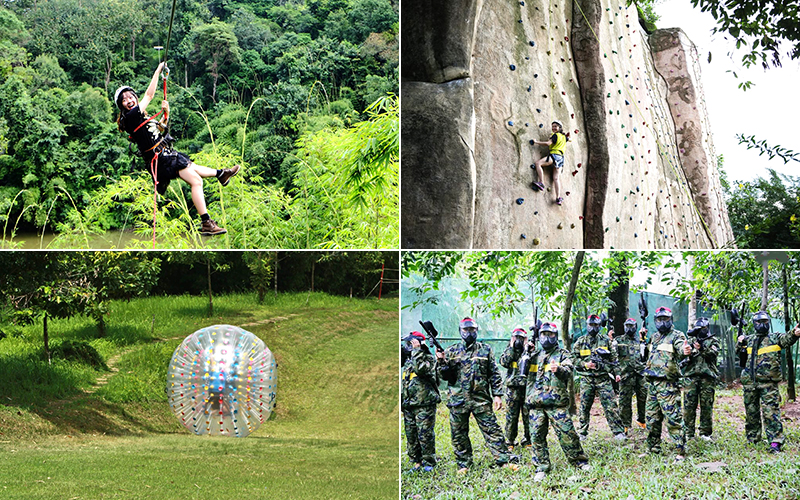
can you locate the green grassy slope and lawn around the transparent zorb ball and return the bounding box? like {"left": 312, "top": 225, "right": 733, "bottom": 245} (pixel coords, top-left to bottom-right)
{"left": 0, "top": 294, "right": 398, "bottom": 499}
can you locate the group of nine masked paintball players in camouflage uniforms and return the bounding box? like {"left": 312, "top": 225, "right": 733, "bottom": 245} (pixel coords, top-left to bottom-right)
{"left": 401, "top": 307, "right": 800, "bottom": 481}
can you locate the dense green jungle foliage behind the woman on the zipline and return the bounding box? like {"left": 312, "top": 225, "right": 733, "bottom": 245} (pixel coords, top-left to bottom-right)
{"left": 0, "top": 0, "right": 399, "bottom": 248}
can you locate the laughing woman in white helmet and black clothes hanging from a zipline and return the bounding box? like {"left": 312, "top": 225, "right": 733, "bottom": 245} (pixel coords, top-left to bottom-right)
{"left": 114, "top": 63, "right": 240, "bottom": 236}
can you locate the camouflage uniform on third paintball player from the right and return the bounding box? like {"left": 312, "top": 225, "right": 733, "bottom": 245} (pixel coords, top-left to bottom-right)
{"left": 644, "top": 329, "right": 686, "bottom": 454}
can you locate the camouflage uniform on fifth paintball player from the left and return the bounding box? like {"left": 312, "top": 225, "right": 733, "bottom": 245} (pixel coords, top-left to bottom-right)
{"left": 572, "top": 333, "right": 625, "bottom": 436}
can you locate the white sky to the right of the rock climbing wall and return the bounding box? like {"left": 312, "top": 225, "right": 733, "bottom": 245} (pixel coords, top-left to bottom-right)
{"left": 655, "top": 0, "right": 800, "bottom": 182}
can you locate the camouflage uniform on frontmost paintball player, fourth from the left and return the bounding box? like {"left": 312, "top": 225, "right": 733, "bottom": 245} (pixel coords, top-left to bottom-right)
{"left": 525, "top": 348, "right": 588, "bottom": 472}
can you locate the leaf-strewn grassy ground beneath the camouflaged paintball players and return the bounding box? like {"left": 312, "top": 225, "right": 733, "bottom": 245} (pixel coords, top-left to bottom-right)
{"left": 401, "top": 385, "right": 800, "bottom": 500}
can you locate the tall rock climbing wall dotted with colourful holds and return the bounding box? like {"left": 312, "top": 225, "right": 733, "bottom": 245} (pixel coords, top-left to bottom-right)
{"left": 402, "top": 0, "right": 732, "bottom": 249}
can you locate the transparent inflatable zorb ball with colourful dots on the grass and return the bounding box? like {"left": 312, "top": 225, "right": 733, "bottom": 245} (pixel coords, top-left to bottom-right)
{"left": 167, "top": 325, "right": 278, "bottom": 437}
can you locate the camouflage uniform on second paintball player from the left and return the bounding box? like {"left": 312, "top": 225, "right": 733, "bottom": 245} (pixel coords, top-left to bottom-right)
{"left": 437, "top": 342, "right": 511, "bottom": 468}
